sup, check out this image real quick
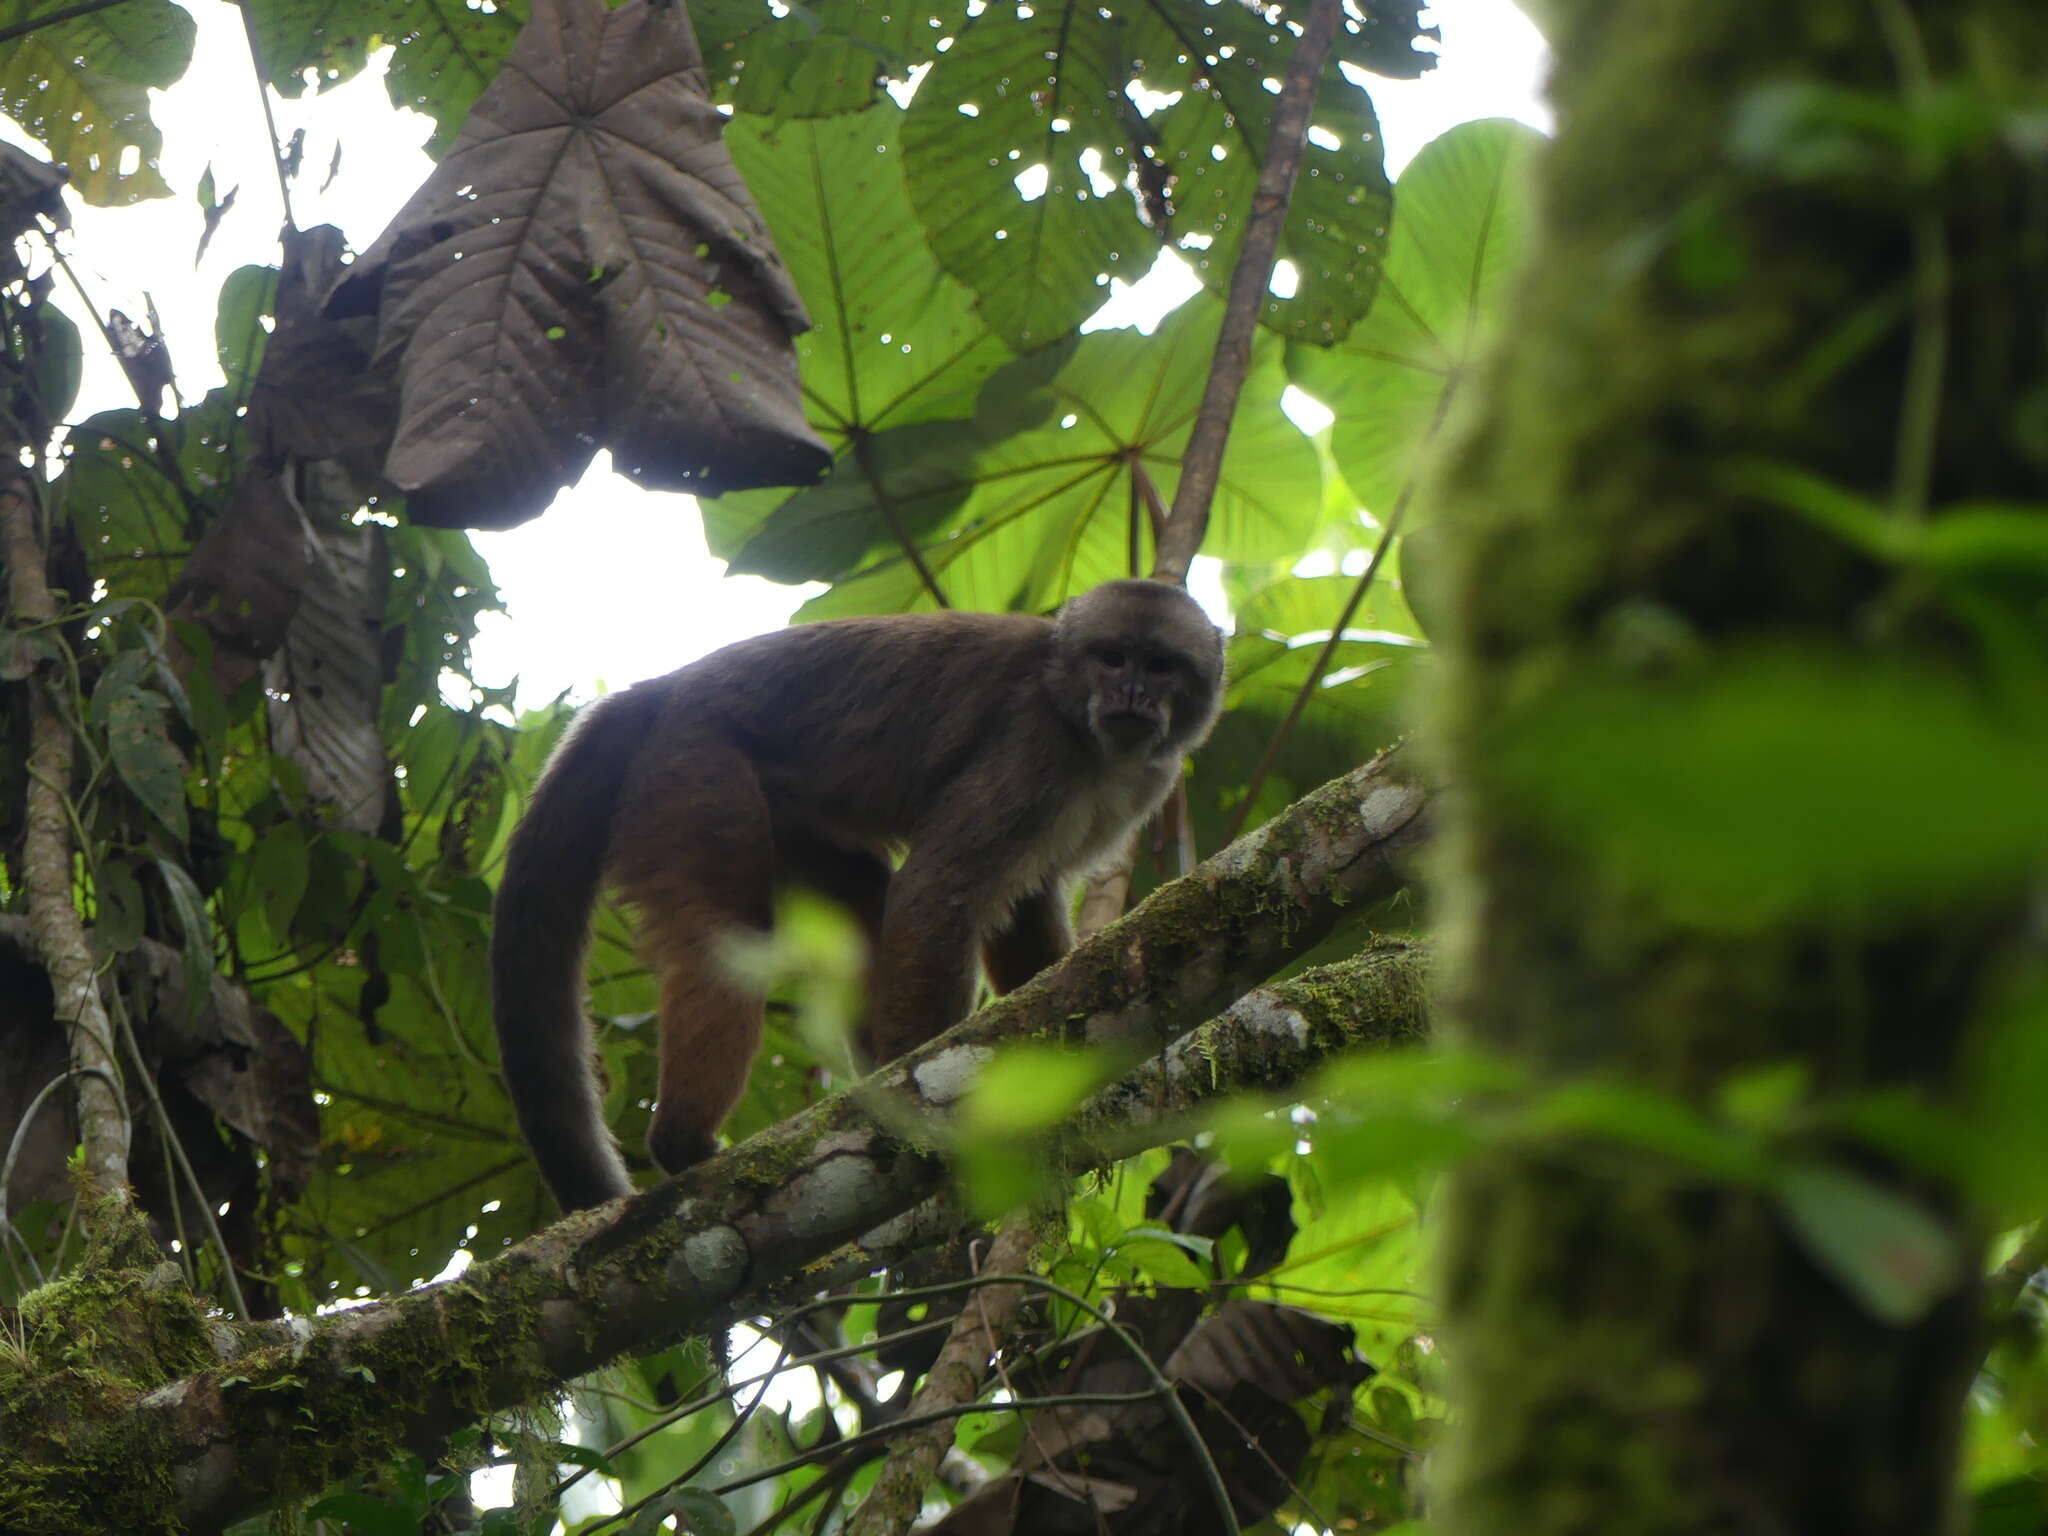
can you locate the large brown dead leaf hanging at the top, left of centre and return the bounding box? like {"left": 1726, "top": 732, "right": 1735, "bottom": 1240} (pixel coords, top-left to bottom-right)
{"left": 330, "top": 0, "right": 829, "bottom": 528}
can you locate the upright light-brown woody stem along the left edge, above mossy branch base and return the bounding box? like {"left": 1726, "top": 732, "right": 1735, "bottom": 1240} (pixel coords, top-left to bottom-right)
{"left": 0, "top": 471, "right": 129, "bottom": 1202}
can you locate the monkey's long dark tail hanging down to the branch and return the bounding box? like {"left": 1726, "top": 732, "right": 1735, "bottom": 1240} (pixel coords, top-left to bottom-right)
{"left": 492, "top": 688, "right": 659, "bottom": 1210}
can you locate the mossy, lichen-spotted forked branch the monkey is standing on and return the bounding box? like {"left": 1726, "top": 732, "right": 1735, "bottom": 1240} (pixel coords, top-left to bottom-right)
{"left": 92, "top": 754, "right": 1427, "bottom": 1532}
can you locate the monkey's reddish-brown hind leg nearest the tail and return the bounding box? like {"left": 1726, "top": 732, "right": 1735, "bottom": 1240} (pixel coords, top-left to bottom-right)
{"left": 612, "top": 735, "right": 776, "bottom": 1174}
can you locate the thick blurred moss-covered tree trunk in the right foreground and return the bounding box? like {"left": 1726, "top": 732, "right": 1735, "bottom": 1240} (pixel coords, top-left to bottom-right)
{"left": 1434, "top": 0, "right": 2048, "bottom": 1536}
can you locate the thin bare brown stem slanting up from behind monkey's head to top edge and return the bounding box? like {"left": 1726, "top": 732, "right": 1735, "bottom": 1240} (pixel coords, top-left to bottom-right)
{"left": 1153, "top": 0, "right": 1341, "bottom": 584}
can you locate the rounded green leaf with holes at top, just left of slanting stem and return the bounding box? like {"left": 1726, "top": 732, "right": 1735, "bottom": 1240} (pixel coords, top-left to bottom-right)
{"left": 903, "top": 0, "right": 1159, "bottom": 350}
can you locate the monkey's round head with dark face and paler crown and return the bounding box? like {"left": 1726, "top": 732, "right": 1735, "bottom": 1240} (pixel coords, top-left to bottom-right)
{"left": 1049, "top": 582, "right": 1223, "bottom": 758}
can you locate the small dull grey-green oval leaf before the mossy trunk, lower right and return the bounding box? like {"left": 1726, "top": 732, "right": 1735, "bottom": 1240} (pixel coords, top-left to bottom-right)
{"left": 1778, "top": 1163, "right": 1962, "bottom": 1327}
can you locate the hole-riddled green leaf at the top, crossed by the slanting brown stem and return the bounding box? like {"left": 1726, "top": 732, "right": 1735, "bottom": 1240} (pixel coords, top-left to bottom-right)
{"left": 1147, "top": 4, "right": 1419, "bottom": 346}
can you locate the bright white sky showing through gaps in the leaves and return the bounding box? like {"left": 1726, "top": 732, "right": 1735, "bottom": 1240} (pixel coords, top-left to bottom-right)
{"left": 32, "top": 0, "right": 1548, "bottom": 705}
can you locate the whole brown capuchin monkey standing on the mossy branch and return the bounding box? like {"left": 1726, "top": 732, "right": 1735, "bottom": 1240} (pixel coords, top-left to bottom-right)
{"left": 492, "top": 582, "right": 1223, "bottom": 1210}
